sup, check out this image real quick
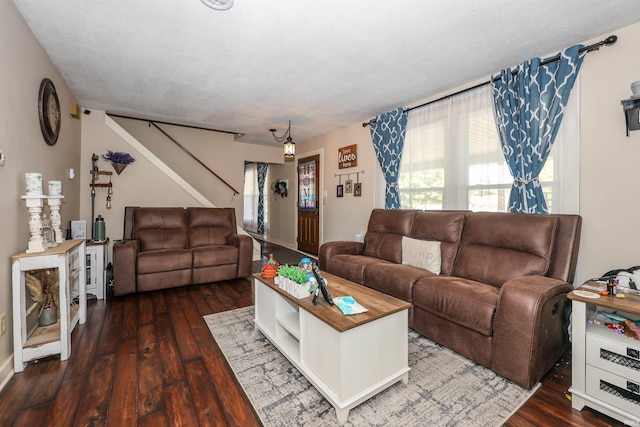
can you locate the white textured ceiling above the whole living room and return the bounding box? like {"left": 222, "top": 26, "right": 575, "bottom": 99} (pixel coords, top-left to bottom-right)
{"left": 14, "top": 0, "right": 640, "bottom": 145}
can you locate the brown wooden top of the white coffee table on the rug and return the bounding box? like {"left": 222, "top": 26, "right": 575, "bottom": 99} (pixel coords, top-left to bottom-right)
{"left": 253, "top": 271, "right": 411, "bottom": 332}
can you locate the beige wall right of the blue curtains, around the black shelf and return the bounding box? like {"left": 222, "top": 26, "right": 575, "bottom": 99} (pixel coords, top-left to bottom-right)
{"left": 580, "top": 24, "right": 640, "bottom": 281}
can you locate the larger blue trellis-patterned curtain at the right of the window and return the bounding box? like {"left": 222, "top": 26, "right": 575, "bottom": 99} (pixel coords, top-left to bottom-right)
{"left": 492, "top": 45, "right": 585, "bottom": 214}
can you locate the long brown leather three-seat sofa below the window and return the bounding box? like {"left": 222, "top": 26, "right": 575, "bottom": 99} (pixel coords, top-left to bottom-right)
{"left": 319, "top": 209, "right": 582, "bottom": 388}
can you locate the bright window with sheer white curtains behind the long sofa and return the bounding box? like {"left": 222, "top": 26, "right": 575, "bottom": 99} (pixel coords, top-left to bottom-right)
{"left": 398, "top": 84, "right": 579, "bottom": 213}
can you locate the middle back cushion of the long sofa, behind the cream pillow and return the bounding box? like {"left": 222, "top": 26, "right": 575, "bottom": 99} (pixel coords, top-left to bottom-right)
{"left": 409, "top": 211, "right": 468, "bottom": 276}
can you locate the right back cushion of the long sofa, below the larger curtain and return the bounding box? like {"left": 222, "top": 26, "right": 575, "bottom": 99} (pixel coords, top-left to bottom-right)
{"left": 453, "top": 212, "right": 559, "bottom": 287}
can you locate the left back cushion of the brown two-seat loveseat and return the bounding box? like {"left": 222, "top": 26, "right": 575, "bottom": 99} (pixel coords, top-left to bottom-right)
{"left": 133, "top": 208, "right": 188, "bottom": 252}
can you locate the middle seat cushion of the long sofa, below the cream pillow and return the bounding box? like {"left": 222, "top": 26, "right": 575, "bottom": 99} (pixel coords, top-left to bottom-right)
{"left": 364, "top": 263, "right": 435, "bottom": 302}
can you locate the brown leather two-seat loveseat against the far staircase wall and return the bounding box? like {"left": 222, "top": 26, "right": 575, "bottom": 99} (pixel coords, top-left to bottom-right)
{"left": 113, "top": 207, "right": 253, "bottom": 295}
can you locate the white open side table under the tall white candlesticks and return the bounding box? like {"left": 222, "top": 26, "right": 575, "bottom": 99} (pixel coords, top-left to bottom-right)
{"left": 11, "top": 240, "right": 87, "bottom": 372}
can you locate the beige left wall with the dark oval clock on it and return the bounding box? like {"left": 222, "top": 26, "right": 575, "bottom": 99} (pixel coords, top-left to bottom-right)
{"left": 0, "top": 1, "right": 80, "bottom": 386}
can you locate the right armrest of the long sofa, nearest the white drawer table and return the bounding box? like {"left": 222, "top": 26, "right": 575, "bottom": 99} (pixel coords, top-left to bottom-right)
{"left": 491, "top": 276, "right": 573, "bottom": 389}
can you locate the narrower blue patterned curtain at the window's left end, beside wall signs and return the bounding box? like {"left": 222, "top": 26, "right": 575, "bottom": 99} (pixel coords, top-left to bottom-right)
{"left": 369, "top": 108, "right": 407, "bottom": 209}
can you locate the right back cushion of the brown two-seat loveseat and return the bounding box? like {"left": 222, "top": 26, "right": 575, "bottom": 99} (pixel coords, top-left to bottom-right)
{"left": 188, "top": 208, "right": 236, "bottom": 248}
